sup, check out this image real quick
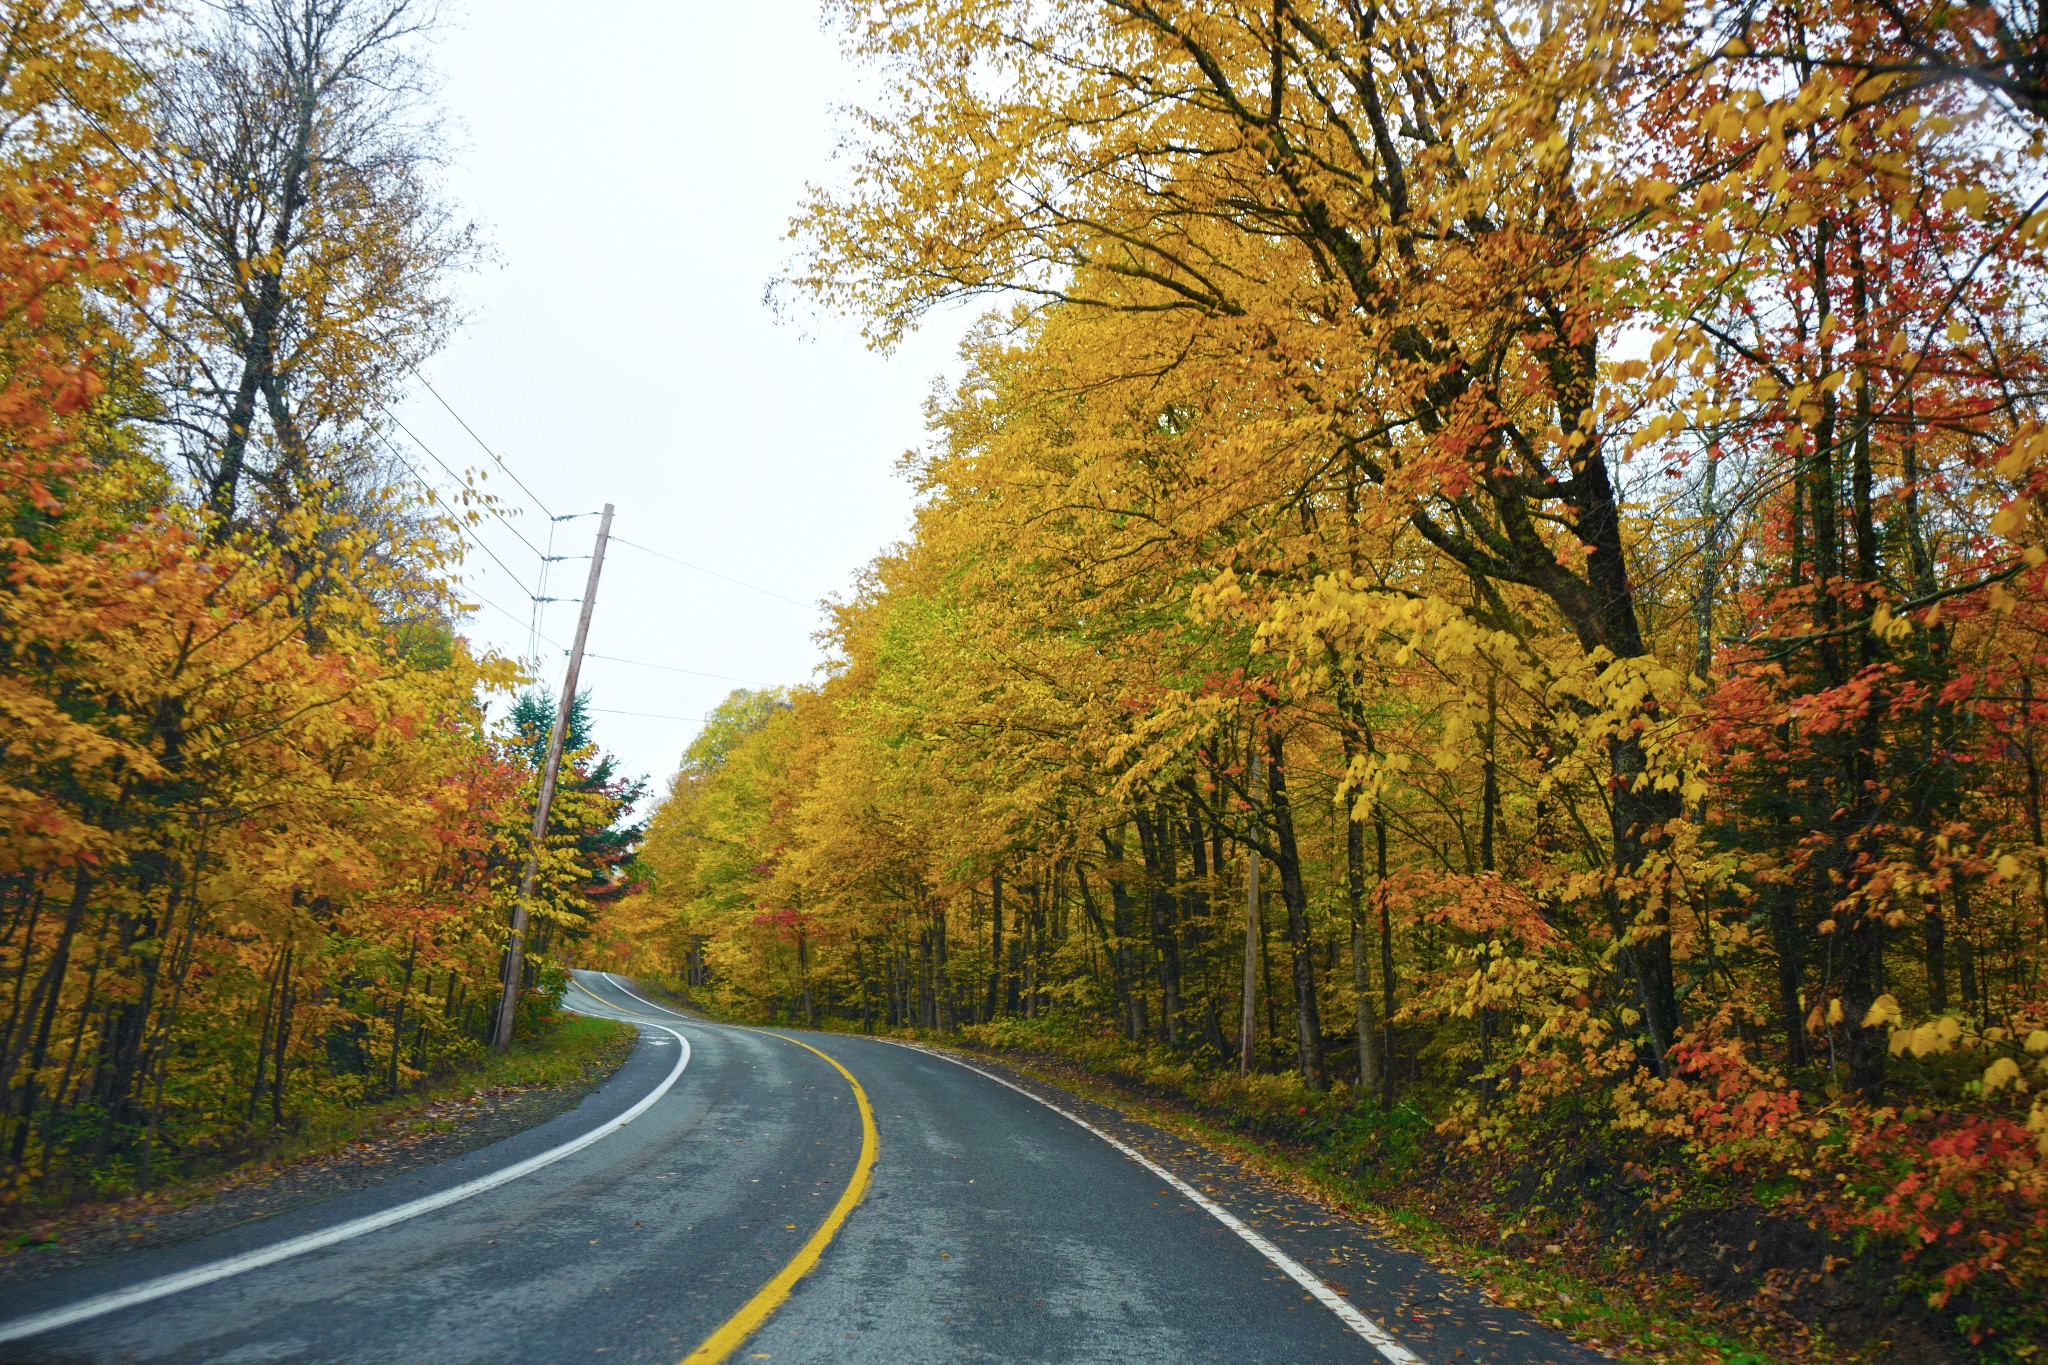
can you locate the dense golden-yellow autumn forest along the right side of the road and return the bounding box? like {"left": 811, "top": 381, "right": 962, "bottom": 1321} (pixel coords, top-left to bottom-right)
{"left": 606, "top": 0, "right": 2048, "bottom": 1359}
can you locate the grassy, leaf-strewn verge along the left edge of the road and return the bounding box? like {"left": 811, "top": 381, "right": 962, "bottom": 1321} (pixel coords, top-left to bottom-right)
{"left": 0, "top": 1015, "right": 637, "bottom": 1261}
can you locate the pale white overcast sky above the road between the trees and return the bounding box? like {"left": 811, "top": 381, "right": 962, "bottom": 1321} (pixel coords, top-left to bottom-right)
{"left": 397, "top": 0, "right": 967, "bottom": 810}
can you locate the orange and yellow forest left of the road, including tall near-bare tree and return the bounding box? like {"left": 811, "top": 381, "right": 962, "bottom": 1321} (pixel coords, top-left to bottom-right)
{"left": 0, "top": 0, "right": 637, "bottom": 1218}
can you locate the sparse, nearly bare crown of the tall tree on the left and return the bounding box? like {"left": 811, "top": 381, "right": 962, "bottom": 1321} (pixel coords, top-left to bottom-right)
{"left": 139, "top": 0, "right": 475, "bottom": 534}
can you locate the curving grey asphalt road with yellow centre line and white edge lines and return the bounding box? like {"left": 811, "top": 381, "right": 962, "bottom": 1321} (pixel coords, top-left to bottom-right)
{"left": 0, "top": 972, "right": 1604, "bottom": 1365}
